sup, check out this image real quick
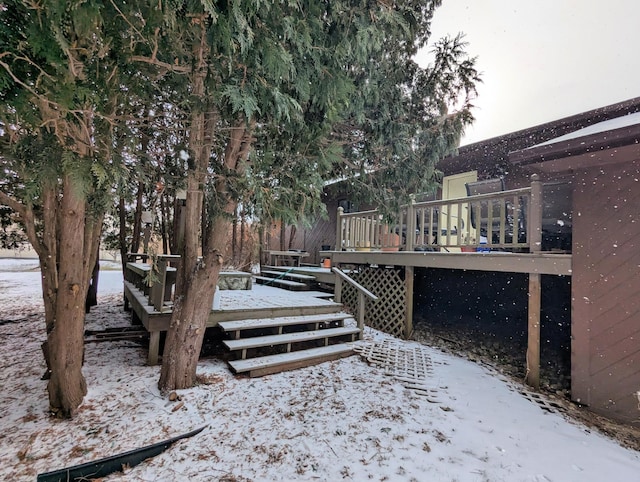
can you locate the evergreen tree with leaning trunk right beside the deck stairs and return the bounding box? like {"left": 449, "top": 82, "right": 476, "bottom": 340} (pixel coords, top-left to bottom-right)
{"left": 112, "top": 0, "right": 475, "bottom": 389}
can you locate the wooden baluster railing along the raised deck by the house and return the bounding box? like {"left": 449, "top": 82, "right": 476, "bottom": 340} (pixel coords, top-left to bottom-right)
{"left": 336, "top": 175, "right": 542, "bottom": 252}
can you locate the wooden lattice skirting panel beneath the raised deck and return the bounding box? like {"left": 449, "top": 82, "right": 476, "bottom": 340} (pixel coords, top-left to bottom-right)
{"left": 342, "top": 266, "right": 407, "bottom": 338}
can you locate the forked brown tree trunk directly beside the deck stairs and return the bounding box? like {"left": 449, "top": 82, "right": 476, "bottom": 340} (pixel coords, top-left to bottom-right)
{"left": 158, "top": 19, "right": 250, "bottom": 391}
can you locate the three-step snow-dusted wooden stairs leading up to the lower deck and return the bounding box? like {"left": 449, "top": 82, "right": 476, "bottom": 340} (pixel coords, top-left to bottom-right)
{"left": 218, "top": 312, "right": 360, "bottom": 377}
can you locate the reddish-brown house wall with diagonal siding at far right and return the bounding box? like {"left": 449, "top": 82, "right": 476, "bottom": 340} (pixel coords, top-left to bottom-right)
{"left": 571, "top": 160, "right": 640, "bottom": 426}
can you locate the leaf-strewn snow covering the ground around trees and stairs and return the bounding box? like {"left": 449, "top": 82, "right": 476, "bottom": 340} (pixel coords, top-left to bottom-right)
{"left": 0, "top": 261, "right": 640, "bottom": 482}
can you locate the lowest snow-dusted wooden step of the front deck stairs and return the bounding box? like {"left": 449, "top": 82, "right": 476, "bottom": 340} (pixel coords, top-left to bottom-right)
{"left": 229, "top": 343, "right": 354, "bottom": 377}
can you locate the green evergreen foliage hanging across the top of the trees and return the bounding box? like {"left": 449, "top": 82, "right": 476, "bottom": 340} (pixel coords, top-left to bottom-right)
{"left": 0, "top": 0, "right": 478, "bottom": 252}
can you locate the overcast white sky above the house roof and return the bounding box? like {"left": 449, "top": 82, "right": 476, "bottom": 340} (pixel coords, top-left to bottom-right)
{"left": 421, "top": 0, "right": 640, "bottom": 145}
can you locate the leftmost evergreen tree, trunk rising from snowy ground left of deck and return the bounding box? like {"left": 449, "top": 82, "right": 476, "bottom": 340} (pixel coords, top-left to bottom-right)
{"left": 0, "top": 0, "right": 126, "bottom": 417}
